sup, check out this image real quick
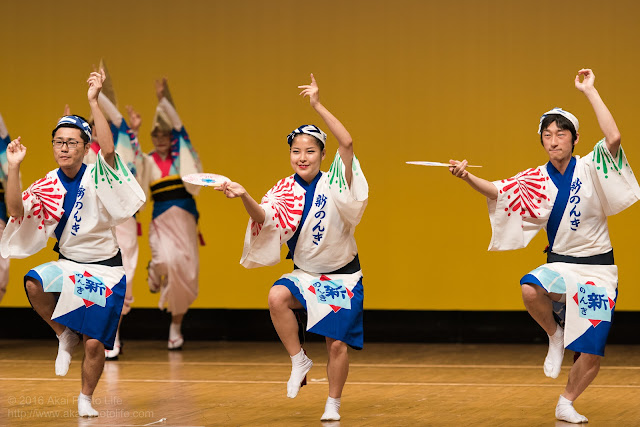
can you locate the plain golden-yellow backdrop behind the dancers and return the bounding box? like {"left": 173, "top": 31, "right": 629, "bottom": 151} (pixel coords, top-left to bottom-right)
{"left": 0, "top": 0, "right": 640, "bottom": 310}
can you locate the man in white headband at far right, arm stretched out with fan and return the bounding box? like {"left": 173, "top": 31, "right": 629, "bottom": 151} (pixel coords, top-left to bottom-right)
{"left": 449, "top": 69, "right": 640, "bottom": 423}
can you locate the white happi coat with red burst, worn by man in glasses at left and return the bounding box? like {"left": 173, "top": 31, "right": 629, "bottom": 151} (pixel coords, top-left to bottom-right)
{"left": 0, "top": 153, "right": 145, "bottom": 342}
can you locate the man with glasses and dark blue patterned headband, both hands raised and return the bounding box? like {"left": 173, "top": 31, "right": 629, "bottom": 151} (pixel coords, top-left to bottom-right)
{"left": 0, "top": 71, "right": 145, "bottom": 417}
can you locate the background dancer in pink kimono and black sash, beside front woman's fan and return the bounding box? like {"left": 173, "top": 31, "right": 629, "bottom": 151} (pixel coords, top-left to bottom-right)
{"left": 143, "top": 78, "right": 202, "bottom": 350}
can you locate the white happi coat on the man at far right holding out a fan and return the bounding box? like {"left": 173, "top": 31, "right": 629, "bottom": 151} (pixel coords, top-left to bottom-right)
{"left": 488, "top": 139, "right": 640, "bottom": 352}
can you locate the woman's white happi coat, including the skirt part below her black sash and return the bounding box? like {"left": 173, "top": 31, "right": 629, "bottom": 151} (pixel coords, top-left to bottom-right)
{"left": 240, "top": 153, "right": 369, "bottom": 342}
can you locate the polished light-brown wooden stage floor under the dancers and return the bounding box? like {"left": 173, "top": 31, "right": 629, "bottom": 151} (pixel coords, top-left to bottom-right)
{"left": 0, "top": 339, "right": 640, "bottom": 427}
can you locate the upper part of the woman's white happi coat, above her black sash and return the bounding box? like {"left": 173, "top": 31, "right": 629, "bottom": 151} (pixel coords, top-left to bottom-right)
{"left": 240, "top": 153, "right": 369, "bottom": 273}
